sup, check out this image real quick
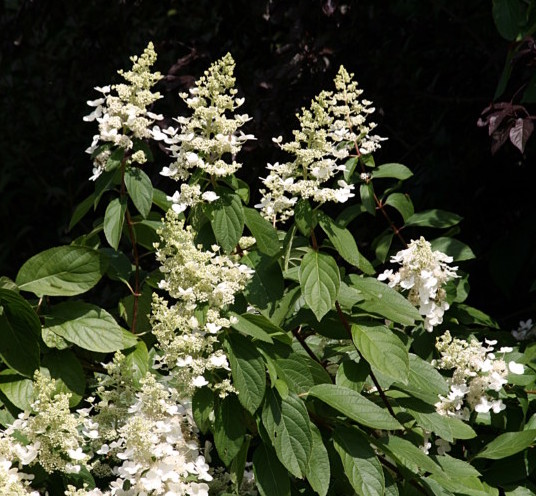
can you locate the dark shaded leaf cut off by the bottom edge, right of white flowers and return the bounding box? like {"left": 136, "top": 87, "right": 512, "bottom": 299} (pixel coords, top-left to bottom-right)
{"left": 253, "top": 444, "right": 290, "bottom": 496}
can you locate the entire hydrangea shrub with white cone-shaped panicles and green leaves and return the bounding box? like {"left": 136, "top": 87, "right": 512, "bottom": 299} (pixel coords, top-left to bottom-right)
{"left": 0, "top": 44, "right": 536, "bottom": 496}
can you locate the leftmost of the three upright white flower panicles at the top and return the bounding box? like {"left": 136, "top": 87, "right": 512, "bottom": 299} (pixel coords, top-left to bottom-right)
{"left": 84, "top": 43, "right": 163, "bottom": 180}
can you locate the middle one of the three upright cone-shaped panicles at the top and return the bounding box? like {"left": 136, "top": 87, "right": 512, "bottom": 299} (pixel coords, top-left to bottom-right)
{"left": 153, "top": 54, "right": 255, "bottom": 192}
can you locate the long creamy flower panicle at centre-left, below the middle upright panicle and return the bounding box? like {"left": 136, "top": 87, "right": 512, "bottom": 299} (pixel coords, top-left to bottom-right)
{"left": 151, "top": 210, "right": 253, "bottom": 395}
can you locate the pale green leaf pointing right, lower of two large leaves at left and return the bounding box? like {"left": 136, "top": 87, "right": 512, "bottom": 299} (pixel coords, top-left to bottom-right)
{"left": 44, "top": 301, "right": 138, "bottom": 353}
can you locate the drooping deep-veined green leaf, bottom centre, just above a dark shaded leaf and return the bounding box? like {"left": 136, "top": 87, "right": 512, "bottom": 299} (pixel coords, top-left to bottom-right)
{"left": 262, "top": 390, "right": 313, "bottom": 478}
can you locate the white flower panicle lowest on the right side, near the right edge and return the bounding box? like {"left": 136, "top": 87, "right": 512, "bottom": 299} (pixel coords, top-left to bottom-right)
{"left": 433, "top": 331, "right": 524, "bottom": 420}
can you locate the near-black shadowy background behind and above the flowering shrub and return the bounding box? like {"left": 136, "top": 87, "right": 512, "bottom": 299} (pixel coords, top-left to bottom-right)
{"left": 0, "top": 0, "right": 536, "bottom": 330}
